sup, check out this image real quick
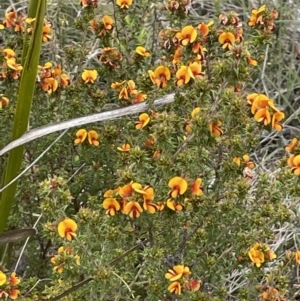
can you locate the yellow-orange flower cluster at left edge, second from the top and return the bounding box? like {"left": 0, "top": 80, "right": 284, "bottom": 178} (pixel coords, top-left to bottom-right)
{"left": 0, "top": 48, "right": 23, "bottom": 79}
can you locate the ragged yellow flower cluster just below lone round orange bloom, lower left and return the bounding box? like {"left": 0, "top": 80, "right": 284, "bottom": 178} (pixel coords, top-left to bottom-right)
{"left": 50, "top": 247, "right": 80, "bottom": 274}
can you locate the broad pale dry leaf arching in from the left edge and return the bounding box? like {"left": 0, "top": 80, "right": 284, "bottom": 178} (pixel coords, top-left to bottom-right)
{"left": 0, "top": 93, "right": 175, "bottom": 156}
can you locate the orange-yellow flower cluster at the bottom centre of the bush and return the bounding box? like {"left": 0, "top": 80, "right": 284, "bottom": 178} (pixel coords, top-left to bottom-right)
{"left": 165, "top": 265, "right": 201, "bottom": 295}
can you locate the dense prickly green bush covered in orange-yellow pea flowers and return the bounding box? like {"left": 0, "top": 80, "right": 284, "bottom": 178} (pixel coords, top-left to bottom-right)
{"left": 0, "top": 0, "right": 300, "bottom": 301}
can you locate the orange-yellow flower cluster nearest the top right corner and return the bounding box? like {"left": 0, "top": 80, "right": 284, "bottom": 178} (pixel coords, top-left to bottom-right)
{"left": 248, "top": 5, "right": 278, "bottom": 31}
